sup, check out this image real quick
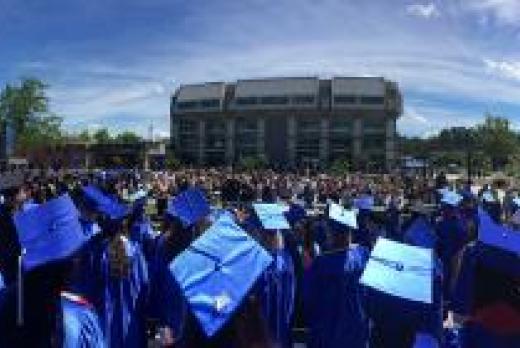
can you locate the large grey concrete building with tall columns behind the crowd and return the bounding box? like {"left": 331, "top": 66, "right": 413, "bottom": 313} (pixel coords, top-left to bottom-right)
{"left": 171, "top": 77, "right": 402, "bottom": 168}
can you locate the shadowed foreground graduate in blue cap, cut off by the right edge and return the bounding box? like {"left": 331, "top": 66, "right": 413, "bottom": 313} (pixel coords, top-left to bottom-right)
{"left": 453, "top": 209, "right": 520, "bottom": 348}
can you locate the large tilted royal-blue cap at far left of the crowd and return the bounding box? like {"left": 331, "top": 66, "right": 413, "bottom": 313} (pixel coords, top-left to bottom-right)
{"left": 14, "top": 194, "right": 88, "bottom": 271}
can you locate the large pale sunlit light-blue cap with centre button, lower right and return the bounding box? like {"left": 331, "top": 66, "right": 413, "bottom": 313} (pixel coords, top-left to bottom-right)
{"left": 360, "top": 238, "right": 433, "bottom": 305}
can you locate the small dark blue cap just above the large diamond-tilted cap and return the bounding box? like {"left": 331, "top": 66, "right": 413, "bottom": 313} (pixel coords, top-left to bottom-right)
{"left": 167, "top": 188, "right": 210, "bottom": 228}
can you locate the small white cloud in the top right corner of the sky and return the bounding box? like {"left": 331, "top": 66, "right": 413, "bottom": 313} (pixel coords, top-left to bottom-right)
{"left": 462, "top": 0, "right": 520, "bottom": 26}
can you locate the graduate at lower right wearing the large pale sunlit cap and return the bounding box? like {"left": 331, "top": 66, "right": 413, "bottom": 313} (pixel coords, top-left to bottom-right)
{"left": 360, "top": 238, "right": 441, "bottom": 348}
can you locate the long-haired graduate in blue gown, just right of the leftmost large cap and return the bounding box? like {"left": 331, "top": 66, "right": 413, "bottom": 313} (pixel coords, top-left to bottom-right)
{"left": 84, "top": 186, "right": 149, "bottom": 347}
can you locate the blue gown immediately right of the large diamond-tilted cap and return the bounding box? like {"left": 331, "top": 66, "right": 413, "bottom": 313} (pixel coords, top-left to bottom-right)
{"left": 257, "top": 249, "right": 296, "bottom": 347}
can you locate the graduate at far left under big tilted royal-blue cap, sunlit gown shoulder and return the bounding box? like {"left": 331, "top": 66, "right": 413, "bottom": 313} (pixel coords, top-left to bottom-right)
{"left": 0, "top": 194, "right": 106, "bottom": 348}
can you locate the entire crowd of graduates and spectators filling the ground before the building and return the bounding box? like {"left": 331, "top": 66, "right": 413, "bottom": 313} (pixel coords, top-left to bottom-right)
{"left": 0, "top": 169, "right": 520, "bottom": 348}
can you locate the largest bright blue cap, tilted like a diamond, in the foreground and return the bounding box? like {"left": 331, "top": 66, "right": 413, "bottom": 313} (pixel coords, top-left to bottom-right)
{"left": 169, "top": 217, "right": 273, "bottom": 337}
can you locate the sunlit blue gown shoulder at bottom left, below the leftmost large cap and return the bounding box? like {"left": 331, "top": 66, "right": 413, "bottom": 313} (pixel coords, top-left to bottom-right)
{"left": 61, "top": 295, "right": 107, "bottom": 348}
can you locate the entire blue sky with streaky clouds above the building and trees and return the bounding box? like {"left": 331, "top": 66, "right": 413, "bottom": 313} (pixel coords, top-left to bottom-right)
{"left": 0, "top": 0, "right": 520, "bottom": 136}
